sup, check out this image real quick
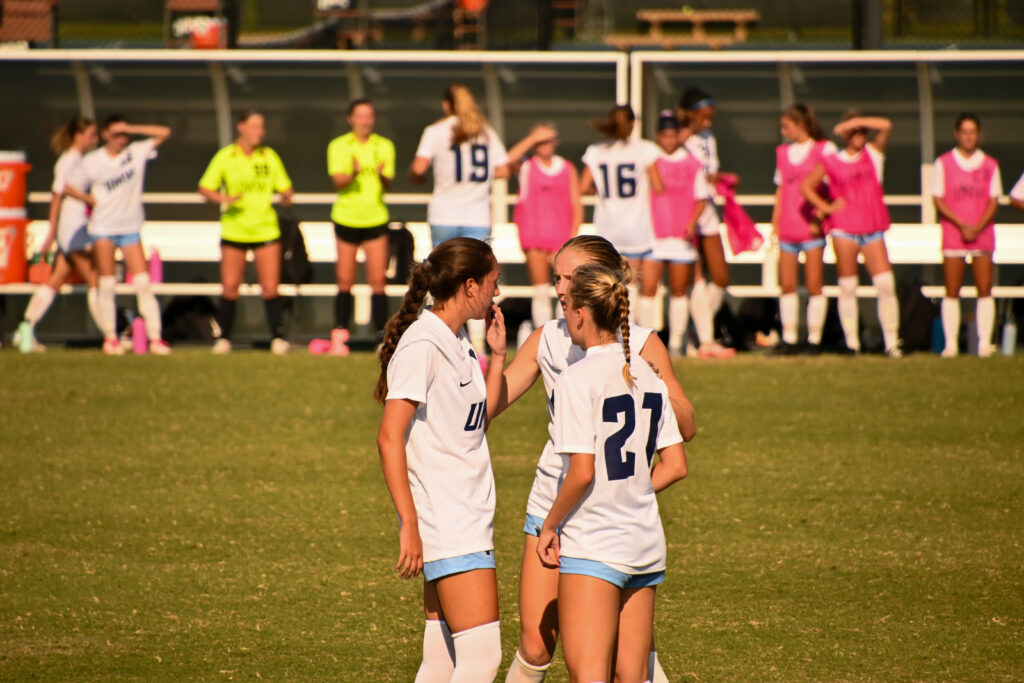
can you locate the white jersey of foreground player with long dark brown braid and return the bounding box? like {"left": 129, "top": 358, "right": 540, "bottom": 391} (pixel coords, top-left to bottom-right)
{"left": 387, "top": 310, "right": 495, "bottom": 562}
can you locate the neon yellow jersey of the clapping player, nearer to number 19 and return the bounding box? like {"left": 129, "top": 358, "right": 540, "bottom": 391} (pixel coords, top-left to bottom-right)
{"left": 327, "top": 133, "right": 394, "bottom": 227}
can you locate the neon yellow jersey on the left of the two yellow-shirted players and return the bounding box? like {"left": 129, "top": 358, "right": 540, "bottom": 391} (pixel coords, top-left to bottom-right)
{"left": 199, "top": 142, "right": 292, "bottom": 242}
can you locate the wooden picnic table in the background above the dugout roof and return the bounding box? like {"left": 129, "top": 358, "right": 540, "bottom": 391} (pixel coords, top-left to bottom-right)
{"left": 604, "top": 9, "right": 761, "bottom": 50}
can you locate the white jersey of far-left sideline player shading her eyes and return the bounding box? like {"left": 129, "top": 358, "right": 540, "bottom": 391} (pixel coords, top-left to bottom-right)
{"left": 69, "top": 137, "right": 157, "bottom": 237}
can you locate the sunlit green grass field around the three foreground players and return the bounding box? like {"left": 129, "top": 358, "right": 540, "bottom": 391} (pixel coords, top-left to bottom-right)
{"left": 0, "top": 349, "right": 1024, "bottom": 681}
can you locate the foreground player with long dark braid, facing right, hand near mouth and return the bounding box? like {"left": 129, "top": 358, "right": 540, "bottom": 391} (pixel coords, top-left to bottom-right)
{"left": 375, "top": 238, "right": 505, "bottom": 683}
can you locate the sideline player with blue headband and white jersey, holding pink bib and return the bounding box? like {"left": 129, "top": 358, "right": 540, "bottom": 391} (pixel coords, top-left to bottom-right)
{"left": 680, "top": 87, "right": 736, "bottom": 358}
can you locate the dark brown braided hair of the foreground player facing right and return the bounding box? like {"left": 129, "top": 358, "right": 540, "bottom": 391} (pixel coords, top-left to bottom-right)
{"left": 374, "top": 238, "right": 498, "bottom": 403}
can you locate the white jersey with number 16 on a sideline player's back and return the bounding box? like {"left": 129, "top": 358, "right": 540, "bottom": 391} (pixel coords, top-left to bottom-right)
{"left": 583, "top": 137, "right": 662, "bottom": 254}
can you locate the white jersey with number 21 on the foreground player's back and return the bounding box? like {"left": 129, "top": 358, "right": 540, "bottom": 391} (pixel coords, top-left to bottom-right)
{"left": 554, "top": 344, "right": 683, "bottom": 573}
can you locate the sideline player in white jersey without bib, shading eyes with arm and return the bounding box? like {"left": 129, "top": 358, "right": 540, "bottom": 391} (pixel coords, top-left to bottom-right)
{"left": 67, "top": 115, "right": 171, "bottom": 355}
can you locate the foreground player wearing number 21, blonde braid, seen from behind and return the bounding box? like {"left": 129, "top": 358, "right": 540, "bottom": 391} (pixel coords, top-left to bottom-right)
{"left": 538, "top": 264, "right": 686, "bottom": 682}
